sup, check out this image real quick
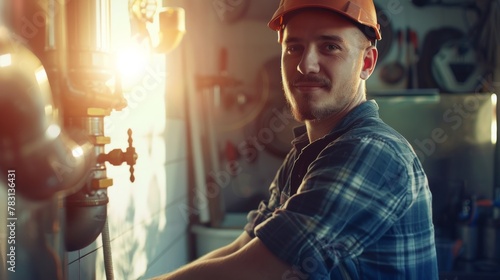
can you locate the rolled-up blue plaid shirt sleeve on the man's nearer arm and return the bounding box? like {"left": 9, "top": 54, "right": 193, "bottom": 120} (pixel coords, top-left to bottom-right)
{"left": 255, "top": 135, "right": 412, "bottom": 278}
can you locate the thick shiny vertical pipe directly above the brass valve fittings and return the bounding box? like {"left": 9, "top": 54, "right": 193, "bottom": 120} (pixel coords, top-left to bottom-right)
{"left": 57, "top": 0, "right": 126, "bottom": 110}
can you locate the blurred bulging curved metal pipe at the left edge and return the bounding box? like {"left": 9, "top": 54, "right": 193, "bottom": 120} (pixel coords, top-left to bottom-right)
{"left": 0, "top": 29, "right": 95, "bottom": 200}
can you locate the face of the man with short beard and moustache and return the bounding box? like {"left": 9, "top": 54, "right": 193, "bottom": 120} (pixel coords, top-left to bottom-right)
{"left": 281, "top": 9, "right": 376, "bottom": 121}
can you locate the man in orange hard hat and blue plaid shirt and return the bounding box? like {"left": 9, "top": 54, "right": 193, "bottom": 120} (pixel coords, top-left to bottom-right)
{"left": 152, "top": 0, "right": 437, "bottom": 280}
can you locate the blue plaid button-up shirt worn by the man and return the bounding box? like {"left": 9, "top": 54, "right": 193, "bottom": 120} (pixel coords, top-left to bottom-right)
{"left": 245, "top": 101, "right": 438, "bottom": 280}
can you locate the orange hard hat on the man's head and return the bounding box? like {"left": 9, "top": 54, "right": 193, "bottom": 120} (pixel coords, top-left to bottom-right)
{"left": 268, "top": 0, "right": 382, "bottom": 41}
